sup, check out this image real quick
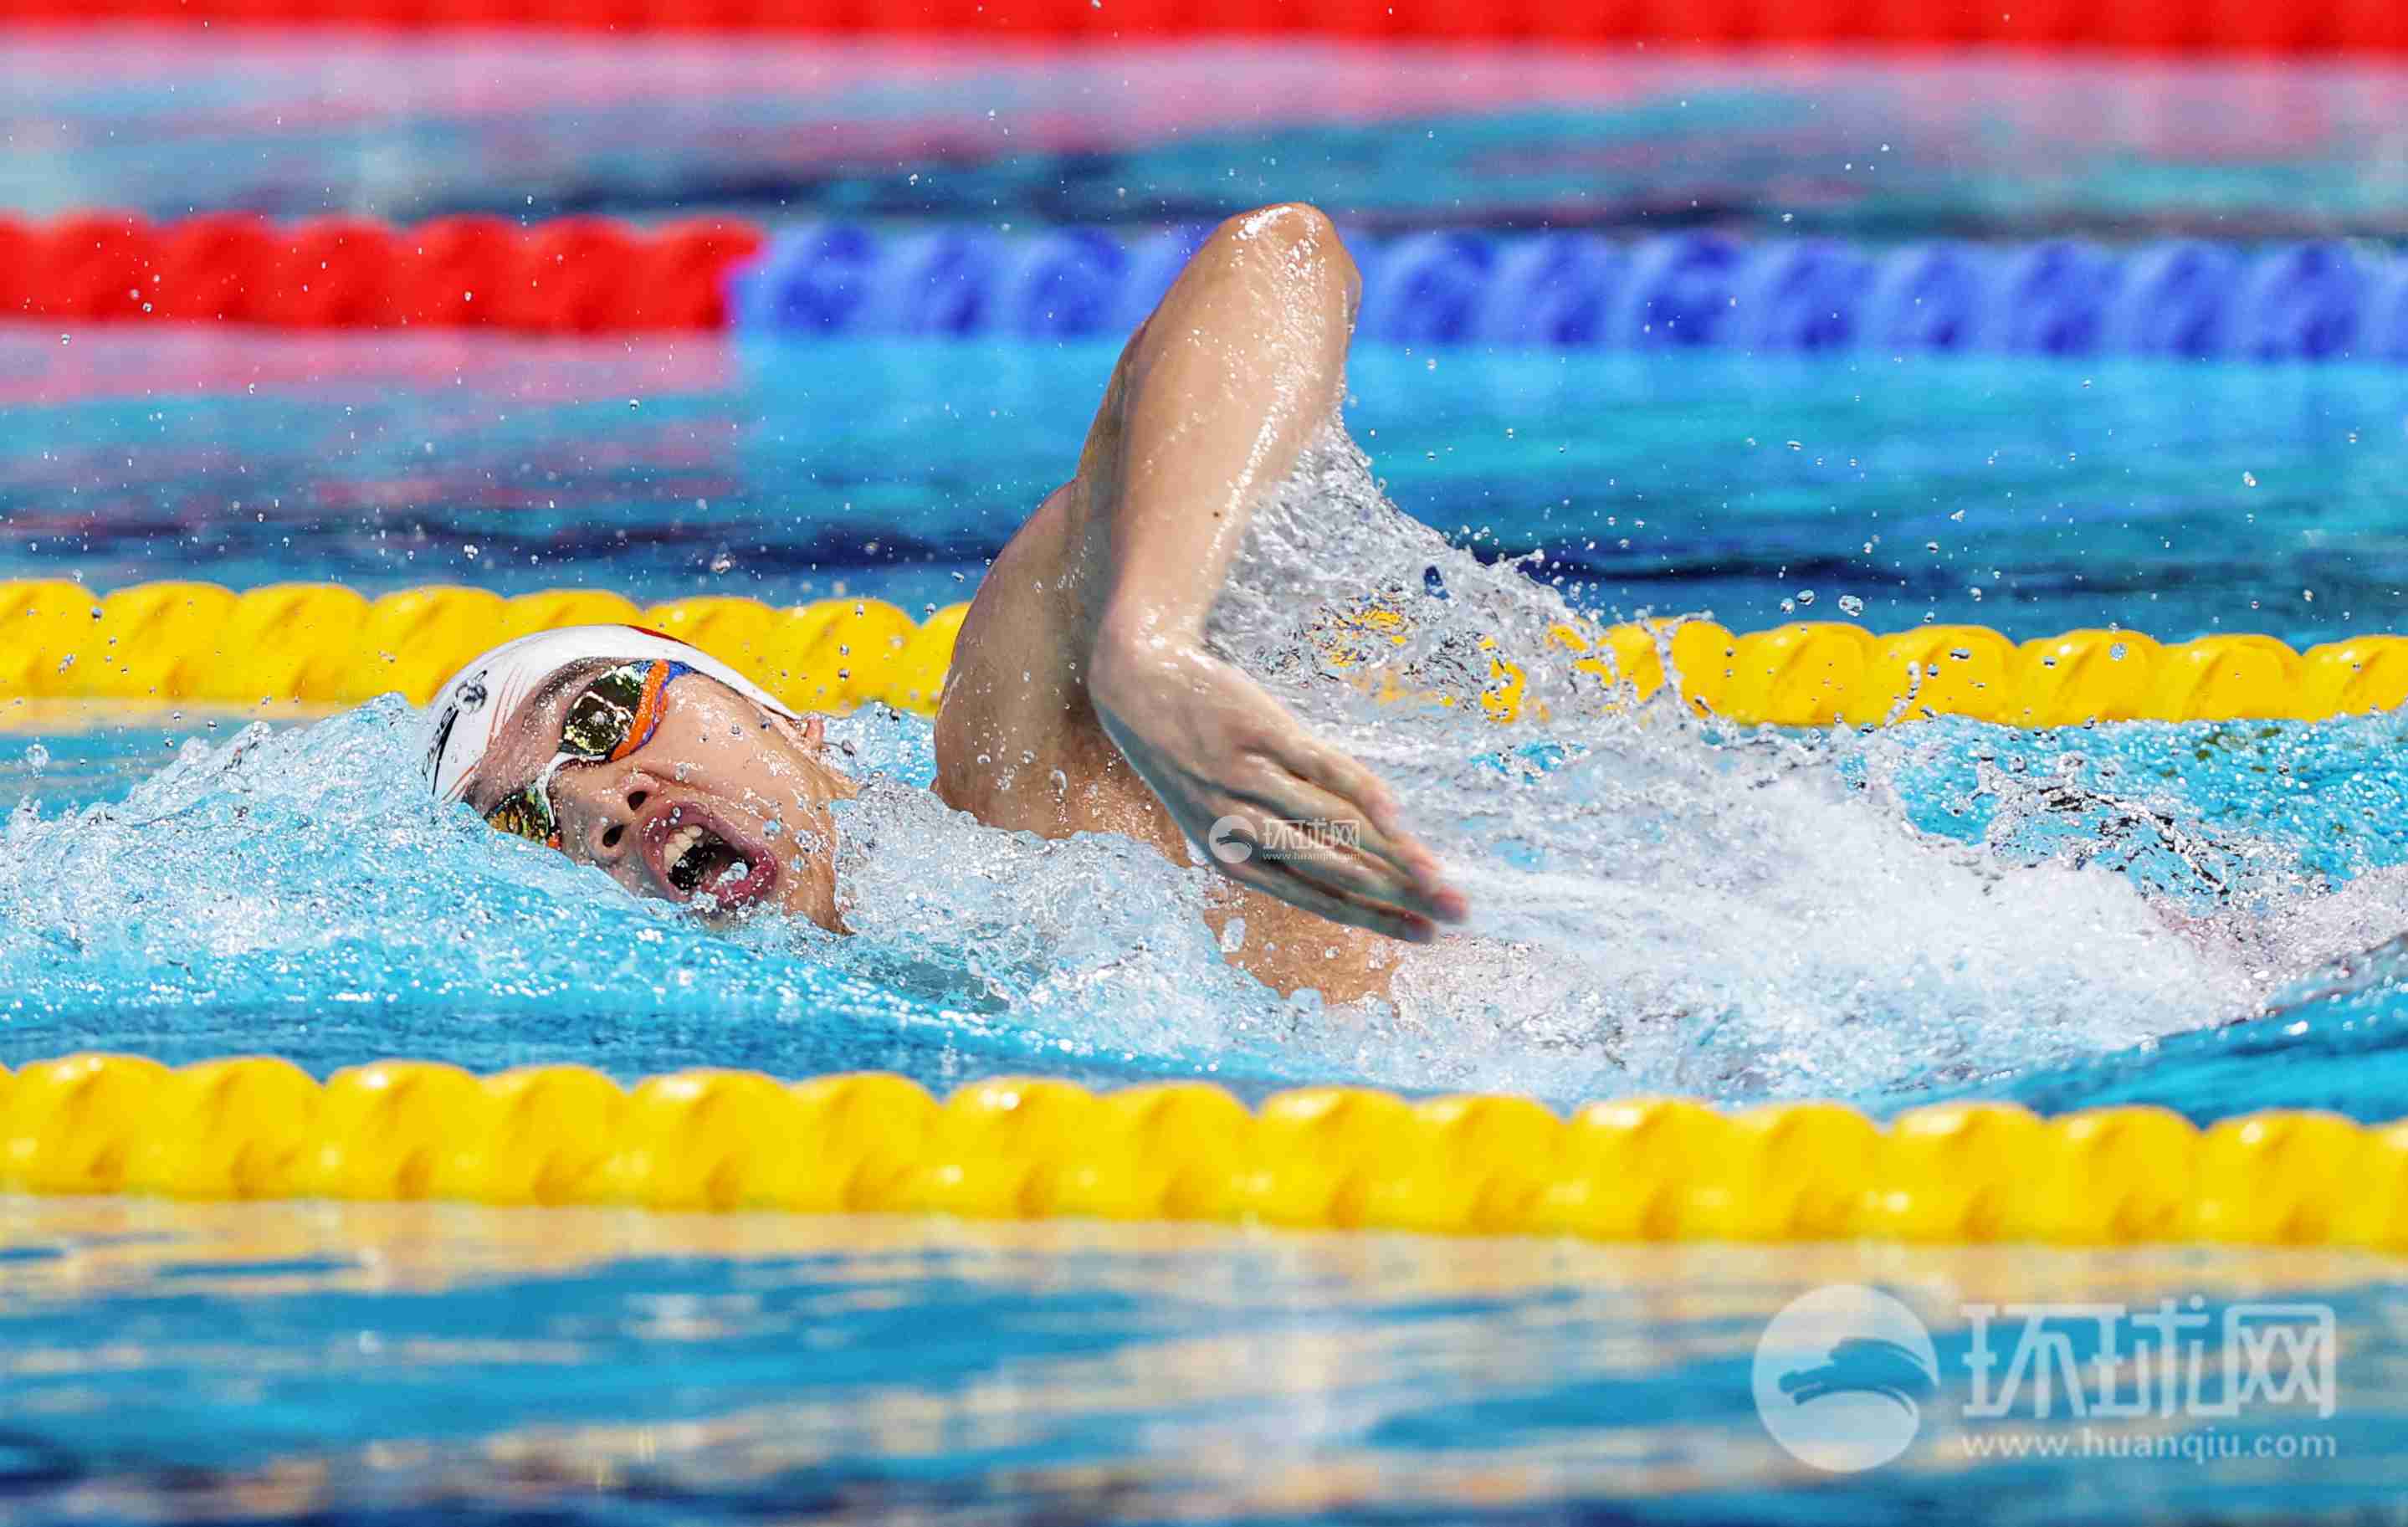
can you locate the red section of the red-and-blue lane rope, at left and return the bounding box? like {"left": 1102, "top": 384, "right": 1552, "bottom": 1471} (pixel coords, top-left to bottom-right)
{"left": 0, "top": 210, "right": 761, "bottom": 335}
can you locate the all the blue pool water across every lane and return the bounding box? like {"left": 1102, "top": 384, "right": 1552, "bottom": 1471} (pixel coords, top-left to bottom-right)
{"left": 0, "top": 31, "right": 2408, "bottom": 1524}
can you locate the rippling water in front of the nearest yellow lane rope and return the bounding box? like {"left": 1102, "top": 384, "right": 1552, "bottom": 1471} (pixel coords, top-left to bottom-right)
{"left": 0, "top": 1202, "right": 2408, "bottom": 1524}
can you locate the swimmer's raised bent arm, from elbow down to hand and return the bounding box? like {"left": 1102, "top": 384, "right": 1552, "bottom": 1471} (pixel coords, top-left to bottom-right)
{"left": 1078, "top": 205, "right": 1467, "bottom": 942}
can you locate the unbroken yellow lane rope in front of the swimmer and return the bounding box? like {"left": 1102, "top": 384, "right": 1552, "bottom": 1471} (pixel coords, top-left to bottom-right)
{"left": 0, "top": 1055, "right": 2408, "bottom": 1250}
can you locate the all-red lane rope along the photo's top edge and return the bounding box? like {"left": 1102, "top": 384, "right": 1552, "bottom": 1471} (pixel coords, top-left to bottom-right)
{"left": 0, "top": 0, "right": 2408, "bottom": 55}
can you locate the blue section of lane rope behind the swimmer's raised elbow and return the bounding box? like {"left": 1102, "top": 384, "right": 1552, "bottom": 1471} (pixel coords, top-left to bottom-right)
{"left": 730, "top": 224, "right": 2408, "bottom": 361}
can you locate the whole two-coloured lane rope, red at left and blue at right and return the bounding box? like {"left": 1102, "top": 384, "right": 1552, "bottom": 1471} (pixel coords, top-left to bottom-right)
{"left": 13, "top": 212, "right": 2408, "bottom": 361}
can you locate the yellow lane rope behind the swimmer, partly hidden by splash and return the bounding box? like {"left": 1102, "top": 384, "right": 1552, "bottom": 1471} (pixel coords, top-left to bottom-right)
{"left": 0, "top": 581, "right": 2408, "bottom": 727}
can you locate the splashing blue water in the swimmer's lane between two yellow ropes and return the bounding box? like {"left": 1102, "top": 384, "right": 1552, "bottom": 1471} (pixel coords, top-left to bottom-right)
{"left": 28, "top": 684, "right": 2408, "bottom": 1122}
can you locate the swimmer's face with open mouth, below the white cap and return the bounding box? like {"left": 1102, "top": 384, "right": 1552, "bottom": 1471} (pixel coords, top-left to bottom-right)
{"left": 467, "top": 658, "right": 853, "bottom": 930}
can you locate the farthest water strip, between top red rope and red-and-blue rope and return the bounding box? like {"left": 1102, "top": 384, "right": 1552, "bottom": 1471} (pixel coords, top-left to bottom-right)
{"left": 0, "top": 36, "right": 2408, "bottom": 238}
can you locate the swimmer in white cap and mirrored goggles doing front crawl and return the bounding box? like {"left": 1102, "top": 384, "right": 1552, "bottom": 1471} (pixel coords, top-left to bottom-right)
{"left": 426, "top": 205, "right": 1467, "bottom": 1002}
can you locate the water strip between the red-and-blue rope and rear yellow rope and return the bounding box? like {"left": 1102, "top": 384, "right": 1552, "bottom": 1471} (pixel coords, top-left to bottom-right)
{"left": 13, "top": 330, "right": 2408, "bottom": 645}
